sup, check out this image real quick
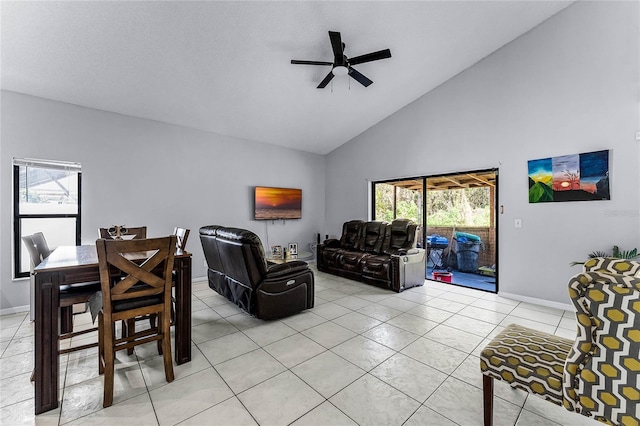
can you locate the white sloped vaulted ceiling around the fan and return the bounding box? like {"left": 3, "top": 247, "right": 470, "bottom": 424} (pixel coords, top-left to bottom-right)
{"left": 0, "top": 1, "right": 571, "bottom": 154}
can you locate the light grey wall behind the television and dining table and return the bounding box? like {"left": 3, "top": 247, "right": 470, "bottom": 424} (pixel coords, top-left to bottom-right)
{"left": 0, "top": 91, "right": 325, "bottom": 312}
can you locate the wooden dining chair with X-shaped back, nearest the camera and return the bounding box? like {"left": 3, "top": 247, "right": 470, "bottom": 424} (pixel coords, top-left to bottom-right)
{"left": 96, "top": 235, "right": 176, "bottom": 407}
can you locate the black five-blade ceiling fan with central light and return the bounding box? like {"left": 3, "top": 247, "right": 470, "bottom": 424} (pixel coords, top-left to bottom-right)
{"left": 291, "top": 31, "right": 391, "bottom": 89}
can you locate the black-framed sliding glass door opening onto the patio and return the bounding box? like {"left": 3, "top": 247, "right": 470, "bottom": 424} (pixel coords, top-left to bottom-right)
{"left": 372, "top": 169, "right": 498, "bottom": 292}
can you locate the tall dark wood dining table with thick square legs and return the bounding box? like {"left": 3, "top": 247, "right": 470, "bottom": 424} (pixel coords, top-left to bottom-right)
{"left": 33, "top": 245, "right": 191, "bottom": 414}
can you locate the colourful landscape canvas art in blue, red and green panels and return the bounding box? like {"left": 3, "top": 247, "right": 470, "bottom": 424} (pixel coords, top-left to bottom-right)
{"left": 528, "top": 150, "right": 611, "bottom": 203}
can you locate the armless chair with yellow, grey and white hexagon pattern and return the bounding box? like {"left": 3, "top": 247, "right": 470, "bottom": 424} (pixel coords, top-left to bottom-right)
{"left": 480, "top": 258, "right": 640, "bottom": 426}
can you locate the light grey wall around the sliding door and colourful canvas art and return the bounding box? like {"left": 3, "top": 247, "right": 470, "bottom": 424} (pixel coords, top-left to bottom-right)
{"left": 325, "top": 2, "right": 640, "bottom": 304}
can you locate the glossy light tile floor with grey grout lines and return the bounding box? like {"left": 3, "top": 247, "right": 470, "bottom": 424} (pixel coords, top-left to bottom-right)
{"left": 0, "top": 265, "right": 597, "bottom": 426}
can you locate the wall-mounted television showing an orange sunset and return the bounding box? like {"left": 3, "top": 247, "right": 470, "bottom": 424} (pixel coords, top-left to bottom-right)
{"left": 253, "top": 186, "right": 302, "bottom": 220}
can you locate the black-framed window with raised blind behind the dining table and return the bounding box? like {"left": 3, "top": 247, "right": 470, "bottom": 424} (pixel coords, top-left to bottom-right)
{"left": 13, "top": 158, "right": 82, "bottom": 278}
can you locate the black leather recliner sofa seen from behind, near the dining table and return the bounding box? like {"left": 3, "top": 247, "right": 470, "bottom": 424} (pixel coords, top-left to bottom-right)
{"left": 200, "top": 225, "right": 314, "bottom": 319}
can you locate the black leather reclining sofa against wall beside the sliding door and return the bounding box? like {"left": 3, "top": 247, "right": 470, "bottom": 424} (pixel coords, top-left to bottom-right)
{"left": 317, "top": 219, "right": 426, "bottom": 293}
